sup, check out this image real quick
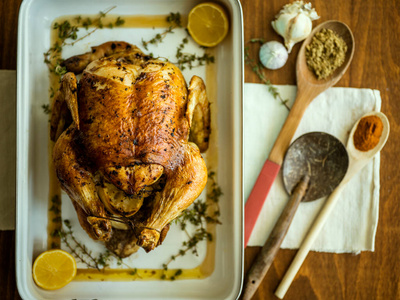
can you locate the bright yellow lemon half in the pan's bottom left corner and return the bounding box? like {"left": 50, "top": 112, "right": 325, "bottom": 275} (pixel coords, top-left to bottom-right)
{"left": 32, "top": 249, "right": 76, "bottom": 290}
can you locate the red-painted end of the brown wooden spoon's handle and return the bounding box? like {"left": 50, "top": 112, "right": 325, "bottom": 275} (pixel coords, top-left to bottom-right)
{"left": 244, "top": 159, "right": 281, "bottom": 247}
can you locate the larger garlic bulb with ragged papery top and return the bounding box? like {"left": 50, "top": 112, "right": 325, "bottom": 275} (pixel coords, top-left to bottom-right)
{"left": 271, "top": 1, "right": 319, "bottom": 53}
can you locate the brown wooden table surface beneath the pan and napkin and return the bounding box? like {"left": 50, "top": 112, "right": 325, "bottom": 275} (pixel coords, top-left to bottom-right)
{"left": 0, "top": 0, "right": 400, "bottom": 300}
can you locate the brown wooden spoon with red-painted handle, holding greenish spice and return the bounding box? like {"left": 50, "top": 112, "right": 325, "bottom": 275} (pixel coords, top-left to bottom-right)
{"left": 244, "top": 21, "right": 354, "bottom": 247}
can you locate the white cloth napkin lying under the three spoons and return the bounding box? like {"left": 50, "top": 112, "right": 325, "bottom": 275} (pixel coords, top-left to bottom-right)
{"left": 244, "top": 83, "right": 381, "bottom": 253}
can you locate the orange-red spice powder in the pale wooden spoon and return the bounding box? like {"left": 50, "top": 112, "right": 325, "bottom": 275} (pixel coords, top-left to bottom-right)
{"left": 353, "top": 116, "right": 383, "bottom": 151}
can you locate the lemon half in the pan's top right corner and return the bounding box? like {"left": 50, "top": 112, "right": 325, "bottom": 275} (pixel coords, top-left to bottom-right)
{"left": 187, "top": 2, "right": 229, "bottom": 47}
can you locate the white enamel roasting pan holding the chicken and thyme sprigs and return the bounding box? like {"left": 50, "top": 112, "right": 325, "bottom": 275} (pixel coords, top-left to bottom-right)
{"left": 16, "top": 0, "right": 243, "bottom": 299}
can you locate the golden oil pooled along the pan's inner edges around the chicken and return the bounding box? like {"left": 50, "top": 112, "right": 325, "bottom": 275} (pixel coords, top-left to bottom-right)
{"left": 47, "top": 15, "right": 218, "bottom": 281}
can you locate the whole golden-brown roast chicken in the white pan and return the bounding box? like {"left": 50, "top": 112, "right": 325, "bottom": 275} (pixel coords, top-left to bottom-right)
{"left": 50, "top": 42, "right": 210, "bottom": 257}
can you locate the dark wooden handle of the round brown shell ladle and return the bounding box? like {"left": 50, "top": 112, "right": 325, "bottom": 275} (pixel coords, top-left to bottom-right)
{"left": 242, "top": 176, "right": 310, "bottom": 300}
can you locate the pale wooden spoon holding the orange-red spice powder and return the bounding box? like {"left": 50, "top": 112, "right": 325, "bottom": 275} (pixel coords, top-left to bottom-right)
{"left": 275, "top": 112, "right": 390, "bottom": 299}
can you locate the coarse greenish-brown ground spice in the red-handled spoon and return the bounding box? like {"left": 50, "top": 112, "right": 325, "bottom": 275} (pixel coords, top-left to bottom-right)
{"left": 306, "top": 28, "right": 347, "bottom": 79}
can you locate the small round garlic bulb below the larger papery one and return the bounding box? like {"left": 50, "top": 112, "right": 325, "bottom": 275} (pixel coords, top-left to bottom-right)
{"left": 260, "top": 41, "right": 288, "bottom": 70}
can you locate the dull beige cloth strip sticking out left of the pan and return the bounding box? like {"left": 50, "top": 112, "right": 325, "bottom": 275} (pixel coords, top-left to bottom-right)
{"left": 0, "top": 70, "right": 16, "bottom": 230}
